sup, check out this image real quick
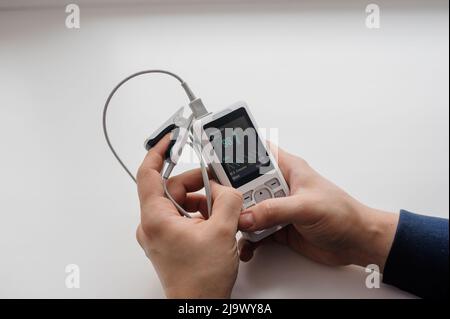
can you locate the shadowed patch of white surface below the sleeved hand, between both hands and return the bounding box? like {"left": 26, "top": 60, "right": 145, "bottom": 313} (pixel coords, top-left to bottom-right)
{"left": 236, "top": 243, "right": 415, "bottom": 298}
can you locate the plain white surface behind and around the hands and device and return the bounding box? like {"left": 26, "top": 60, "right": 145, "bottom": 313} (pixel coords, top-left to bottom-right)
{"left": 0, "top": 1, "right": 449, "bottom": 298}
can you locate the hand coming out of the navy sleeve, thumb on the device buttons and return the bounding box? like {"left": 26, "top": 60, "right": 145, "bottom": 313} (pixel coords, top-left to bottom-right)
{"left": 239, "top": 145, "right": 398, "bottom": 271}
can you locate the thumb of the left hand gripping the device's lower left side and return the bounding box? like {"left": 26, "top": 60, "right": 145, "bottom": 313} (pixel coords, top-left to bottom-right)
{"left": 209, "top": 181, "right": 242, "bottom": 236}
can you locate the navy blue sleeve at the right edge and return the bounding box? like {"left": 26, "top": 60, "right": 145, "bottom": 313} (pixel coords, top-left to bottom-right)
{"left": 383, "top": 210, "right": 449, "bottom": 298}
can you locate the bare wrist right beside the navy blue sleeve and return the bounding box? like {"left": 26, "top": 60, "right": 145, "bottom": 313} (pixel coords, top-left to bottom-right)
{"left": 353, "top": 204, "right": 399, "bottom": 272}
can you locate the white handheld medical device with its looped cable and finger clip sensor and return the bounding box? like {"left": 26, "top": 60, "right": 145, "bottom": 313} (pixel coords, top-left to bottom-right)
{"left": 103, "top": 70, "right": 289, "bottom": 242}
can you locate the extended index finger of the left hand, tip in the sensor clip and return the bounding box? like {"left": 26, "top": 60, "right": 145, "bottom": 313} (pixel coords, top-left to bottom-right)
{"left": 136, "top": 134, "right": 170, "bottom": 202}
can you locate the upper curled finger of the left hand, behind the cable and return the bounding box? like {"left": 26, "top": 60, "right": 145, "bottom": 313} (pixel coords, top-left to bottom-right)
{"left": 167, "top": 168, "right": 203, "bottom": 204}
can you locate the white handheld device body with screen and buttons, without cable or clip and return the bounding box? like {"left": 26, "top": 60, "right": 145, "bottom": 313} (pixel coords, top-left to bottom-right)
{"left": 193, "top": 102, "right": 289, "bottom": 242}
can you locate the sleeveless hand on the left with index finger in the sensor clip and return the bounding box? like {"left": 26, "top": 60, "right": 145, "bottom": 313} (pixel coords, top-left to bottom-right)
{"left": 136, "top": 136, "right": 242, "bottom": 298}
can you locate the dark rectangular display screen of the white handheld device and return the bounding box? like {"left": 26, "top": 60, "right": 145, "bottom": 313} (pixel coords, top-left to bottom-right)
{"left": 203, "top": 107, "right": 273, "bottom": 188}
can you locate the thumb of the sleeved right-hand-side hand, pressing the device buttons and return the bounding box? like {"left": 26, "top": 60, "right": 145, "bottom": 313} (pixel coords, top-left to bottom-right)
{"left": 239, "top": 196, "right": 306, "bottom": 231}
